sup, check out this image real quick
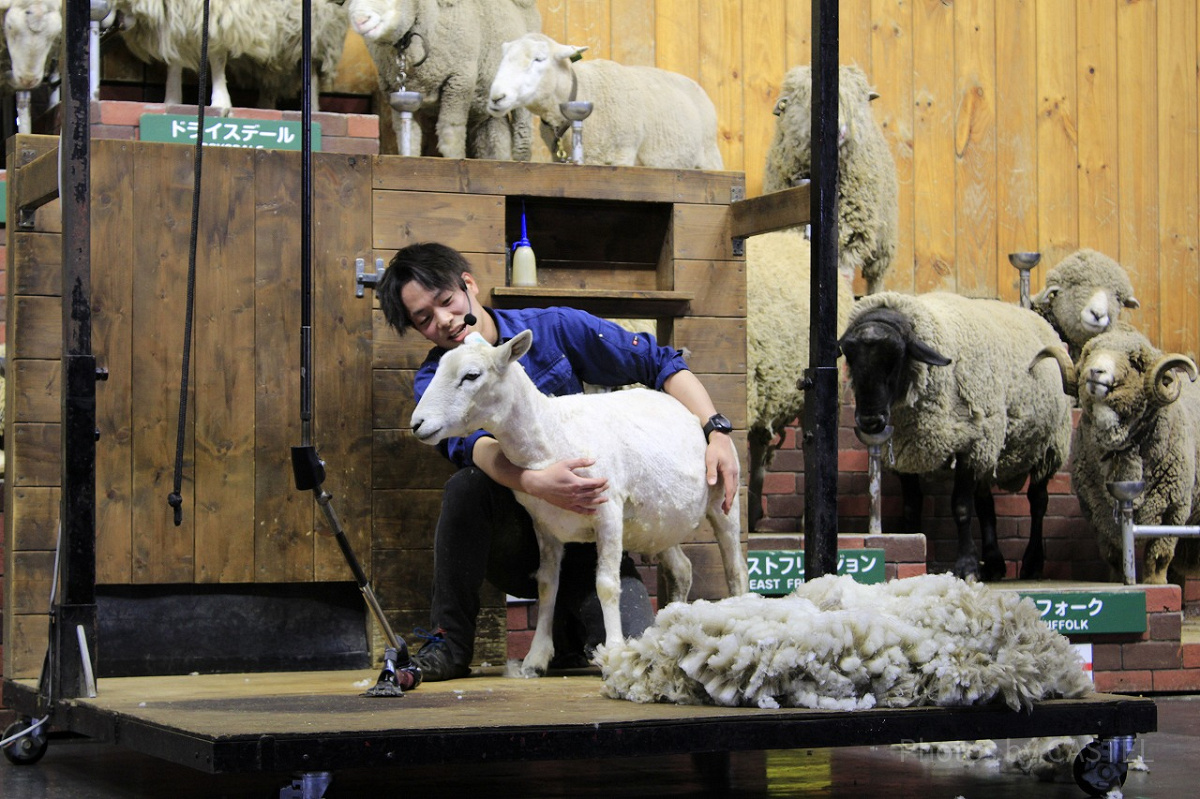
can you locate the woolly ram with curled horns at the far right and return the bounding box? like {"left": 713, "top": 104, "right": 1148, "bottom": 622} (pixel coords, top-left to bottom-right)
{"left": 1045, "top": 326, "right": 1200, "bottom": 583}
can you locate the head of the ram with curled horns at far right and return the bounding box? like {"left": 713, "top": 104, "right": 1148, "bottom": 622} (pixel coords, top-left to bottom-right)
{"left": 1075, "top": 329, "right": 1196, "bottom": 450}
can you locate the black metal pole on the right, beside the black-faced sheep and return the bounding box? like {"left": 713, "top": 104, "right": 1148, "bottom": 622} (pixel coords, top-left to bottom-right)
{"left": 804, "top": 0, "right": 840, "bottom": 579}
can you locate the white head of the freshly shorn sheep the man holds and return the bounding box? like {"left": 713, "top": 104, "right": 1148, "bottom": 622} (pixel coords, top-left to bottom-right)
{"left": 409, "top": 330, "right": 533, "bottom": 444}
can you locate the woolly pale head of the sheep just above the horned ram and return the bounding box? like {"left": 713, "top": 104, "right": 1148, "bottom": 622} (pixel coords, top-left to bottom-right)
{"left": 1032, "top": 248, "right": 1139, "bottom": 359}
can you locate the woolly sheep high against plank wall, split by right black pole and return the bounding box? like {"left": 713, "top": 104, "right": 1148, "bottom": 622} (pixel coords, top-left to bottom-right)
{"left": 762, "top": 66, "right": 900, "bottom": 294}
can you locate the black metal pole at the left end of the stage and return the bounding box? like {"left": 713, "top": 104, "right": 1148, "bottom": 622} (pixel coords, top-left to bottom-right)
{"left": 50, "top": 0, "right": 96, "bottom": 698}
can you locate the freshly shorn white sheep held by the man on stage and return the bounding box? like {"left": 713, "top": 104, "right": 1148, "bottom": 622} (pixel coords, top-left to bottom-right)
{"left": 412, "top": 330, "right": 748, "bottom": 677}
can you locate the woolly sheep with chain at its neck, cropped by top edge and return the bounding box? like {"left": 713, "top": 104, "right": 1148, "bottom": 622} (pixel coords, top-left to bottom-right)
{"left": 346, "top": 0, "right": 541, "bottom": 161}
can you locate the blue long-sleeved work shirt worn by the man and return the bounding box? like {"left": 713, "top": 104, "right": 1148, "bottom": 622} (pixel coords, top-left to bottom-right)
{"left": 413, "top": 308, "right": 688, "bottom": 467}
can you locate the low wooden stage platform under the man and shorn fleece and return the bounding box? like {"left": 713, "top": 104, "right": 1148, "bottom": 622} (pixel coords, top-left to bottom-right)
{"left": 4, "top": 669, "right": 1157, "bottom": 774}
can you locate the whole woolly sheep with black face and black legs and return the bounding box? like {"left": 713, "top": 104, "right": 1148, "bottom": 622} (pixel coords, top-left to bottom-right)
{"left": 839, "top": 292, "right": 1070, "bottom": 579}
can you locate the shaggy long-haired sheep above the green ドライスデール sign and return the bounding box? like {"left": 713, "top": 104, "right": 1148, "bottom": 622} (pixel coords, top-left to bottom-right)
{"left": 114, "top": 0, "right": 348, "bottom": 114}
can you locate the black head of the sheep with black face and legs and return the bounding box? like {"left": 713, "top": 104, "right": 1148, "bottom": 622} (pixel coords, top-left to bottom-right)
{"left": 838, "top": 307, "right": 950, "bottom": 435}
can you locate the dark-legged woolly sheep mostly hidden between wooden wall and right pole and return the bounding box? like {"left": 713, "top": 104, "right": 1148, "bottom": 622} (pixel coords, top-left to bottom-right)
{"left": 746, "top": 230, "right": 854, "bottom": 530}
